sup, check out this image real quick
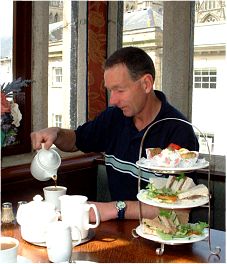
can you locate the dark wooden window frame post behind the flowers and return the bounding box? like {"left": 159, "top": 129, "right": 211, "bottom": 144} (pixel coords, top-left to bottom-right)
{"left": 2, "top": 1, "right": 32, "bottom": 156}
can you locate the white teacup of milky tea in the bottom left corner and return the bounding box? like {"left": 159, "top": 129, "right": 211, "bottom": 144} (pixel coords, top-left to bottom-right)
{"left": 0, "top": 236, "right": 19, "bottom": 263}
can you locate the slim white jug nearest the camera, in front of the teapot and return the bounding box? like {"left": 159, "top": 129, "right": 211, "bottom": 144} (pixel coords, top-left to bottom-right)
{"left": 46, "top": 221, "right": 81, "bottom": 262}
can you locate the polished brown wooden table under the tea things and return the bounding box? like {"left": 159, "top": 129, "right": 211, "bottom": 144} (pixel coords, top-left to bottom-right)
{"left": 2, "top": 220, "right": 226, "bottom": 263}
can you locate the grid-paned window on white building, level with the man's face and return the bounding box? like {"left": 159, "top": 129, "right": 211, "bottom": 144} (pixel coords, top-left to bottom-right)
{"left": 194, "top": 68, "right": 217, "bottom": 89}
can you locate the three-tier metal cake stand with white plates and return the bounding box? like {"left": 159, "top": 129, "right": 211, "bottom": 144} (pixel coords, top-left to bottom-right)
{"left": 132, "top": 118, "right": 221, "bottom": 258}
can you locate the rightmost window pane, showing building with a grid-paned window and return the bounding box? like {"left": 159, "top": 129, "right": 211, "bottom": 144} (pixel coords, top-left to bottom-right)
{"left": 192, "top": 1, "right": 227, "bottom": 155}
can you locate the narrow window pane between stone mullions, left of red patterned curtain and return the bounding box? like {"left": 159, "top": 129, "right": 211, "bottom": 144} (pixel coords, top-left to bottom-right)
{"left": 48, "top": 1, "right": 73, "bottom": 128}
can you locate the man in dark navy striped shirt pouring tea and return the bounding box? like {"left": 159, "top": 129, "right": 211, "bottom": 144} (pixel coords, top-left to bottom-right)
{"left": 31, "top": 47, "right": 198, "bottom": 221}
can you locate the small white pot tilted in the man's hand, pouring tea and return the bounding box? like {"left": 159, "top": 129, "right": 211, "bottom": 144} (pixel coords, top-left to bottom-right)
{"left": 30, "top": 144, "right": 61, "bottom": 181}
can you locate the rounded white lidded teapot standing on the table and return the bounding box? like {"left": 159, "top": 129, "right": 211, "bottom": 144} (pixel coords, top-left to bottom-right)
{"left": 16, "top": 195, "right": 59, "bottom": 243}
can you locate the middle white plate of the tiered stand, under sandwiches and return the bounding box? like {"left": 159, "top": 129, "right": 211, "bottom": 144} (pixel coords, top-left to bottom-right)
{"left": 137, "top": 189, "right": 209, "bottom": 209}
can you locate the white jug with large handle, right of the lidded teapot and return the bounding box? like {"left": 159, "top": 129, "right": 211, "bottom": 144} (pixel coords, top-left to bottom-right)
{"left": 59, "top": 195, "right": 100, "bottom": 240}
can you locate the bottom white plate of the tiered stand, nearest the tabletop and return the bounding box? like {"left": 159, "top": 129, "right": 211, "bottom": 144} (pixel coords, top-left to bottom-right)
{"left": 136, "top": 225, "right": 208, "bottom": 245}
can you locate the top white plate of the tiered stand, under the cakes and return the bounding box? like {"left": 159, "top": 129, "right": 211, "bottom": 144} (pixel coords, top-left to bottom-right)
{"left": 136, "top": 158, "right": 209, "bottom": 174}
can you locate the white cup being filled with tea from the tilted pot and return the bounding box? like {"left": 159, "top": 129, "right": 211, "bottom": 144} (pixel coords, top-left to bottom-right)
{"left": 43, "top": 186, "right": 67, "bottom": 211}
